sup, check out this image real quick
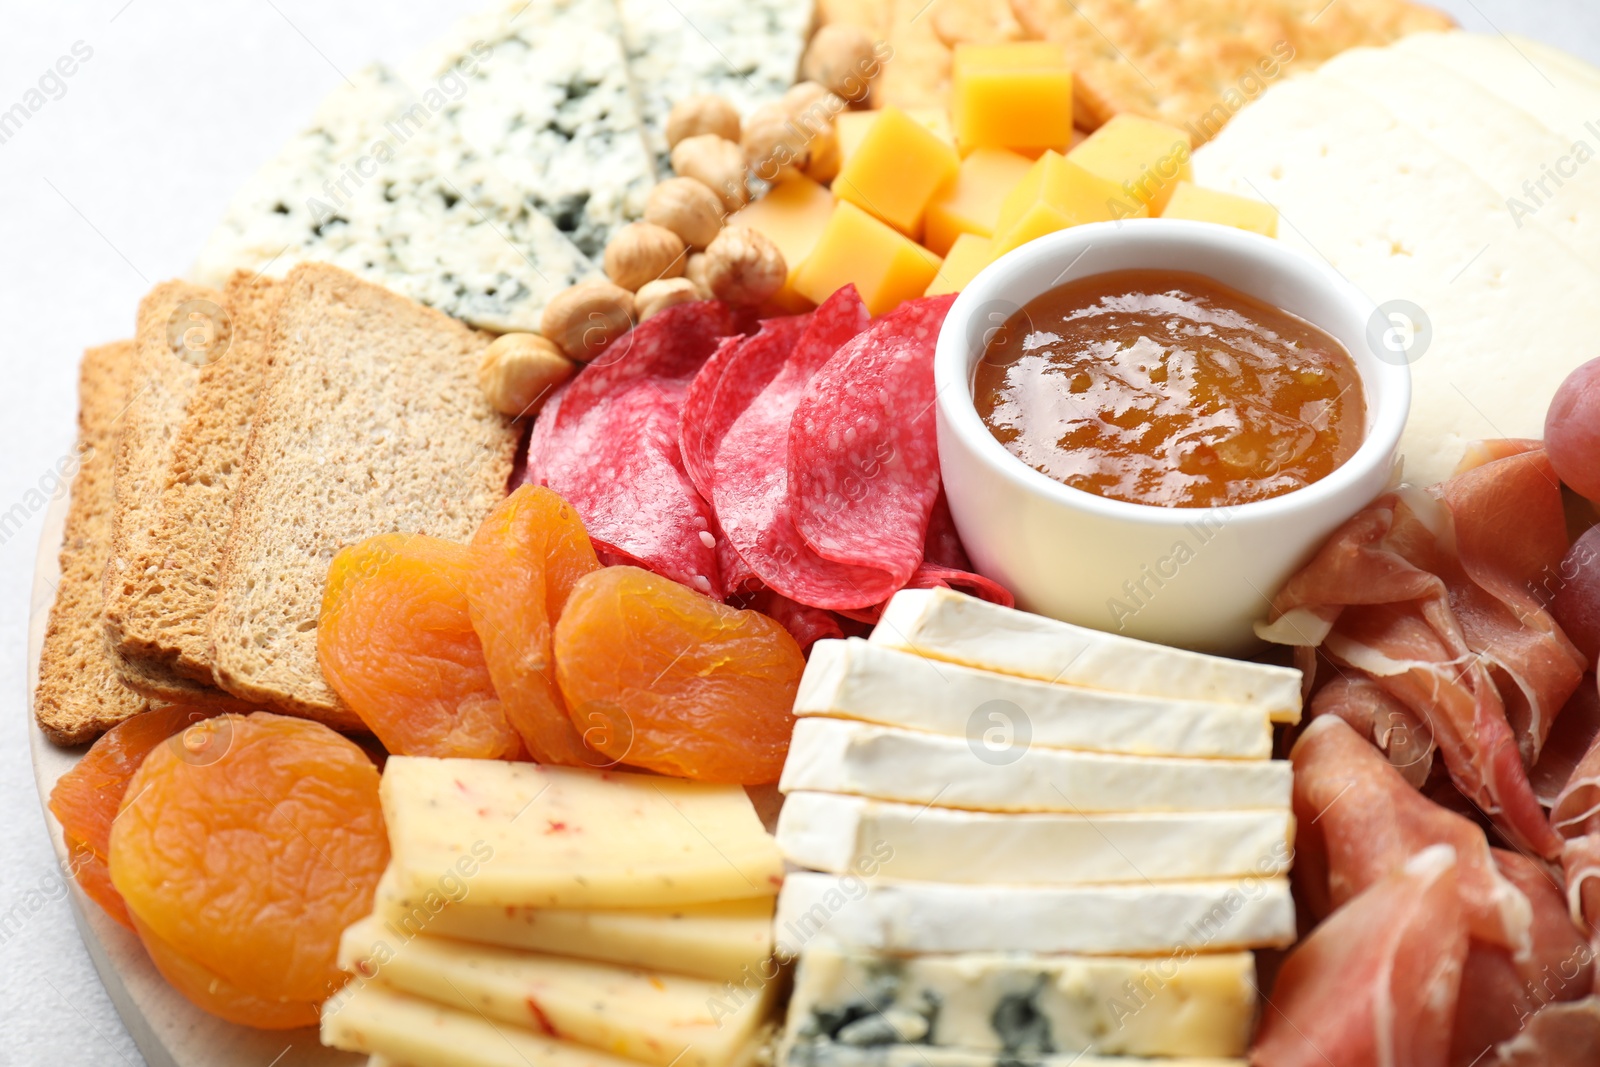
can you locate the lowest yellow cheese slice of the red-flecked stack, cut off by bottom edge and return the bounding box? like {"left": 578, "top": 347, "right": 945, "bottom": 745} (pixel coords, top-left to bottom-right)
{"left": 322, "top": 979, "right": 634, "bottom": 1067}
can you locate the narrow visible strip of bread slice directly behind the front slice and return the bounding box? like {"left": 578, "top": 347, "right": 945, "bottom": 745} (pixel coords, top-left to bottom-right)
{"left": 109, "top": 272, "right": 283, "bottom": 686}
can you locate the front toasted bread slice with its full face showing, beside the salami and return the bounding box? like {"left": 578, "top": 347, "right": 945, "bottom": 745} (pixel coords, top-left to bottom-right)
{"left": 211, "top": 264, "right": 517, "bottom": 728}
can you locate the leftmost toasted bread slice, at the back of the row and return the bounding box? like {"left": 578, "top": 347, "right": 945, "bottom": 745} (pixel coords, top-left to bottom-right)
{"left": 34, "top": 341, "right": 146, "bottom": 745}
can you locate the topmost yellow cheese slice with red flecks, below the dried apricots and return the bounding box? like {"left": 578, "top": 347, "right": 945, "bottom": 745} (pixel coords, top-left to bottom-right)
{"left": 379, "top": 757, "right": 782, "bottom": 907}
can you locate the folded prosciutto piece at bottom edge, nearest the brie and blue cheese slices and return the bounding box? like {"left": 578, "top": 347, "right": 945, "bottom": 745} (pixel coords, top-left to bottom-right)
{"left": 1250, "top": 844, "right": 1467, "bottom": 1067}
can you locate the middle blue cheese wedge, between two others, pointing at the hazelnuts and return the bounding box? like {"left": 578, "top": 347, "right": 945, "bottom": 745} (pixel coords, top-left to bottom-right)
{"left": 405, "top": 0, "right": 670, "bottom": 256}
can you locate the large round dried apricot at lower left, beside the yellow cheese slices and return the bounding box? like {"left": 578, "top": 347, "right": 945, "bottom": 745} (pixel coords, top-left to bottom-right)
{"left": 110, "top": 712, "right": 389, "bottom": 1029}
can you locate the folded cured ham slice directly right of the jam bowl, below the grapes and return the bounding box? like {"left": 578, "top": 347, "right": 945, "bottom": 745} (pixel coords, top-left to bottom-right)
{"left": 1261, "top": 442, "right": 1586, "bottom": 859}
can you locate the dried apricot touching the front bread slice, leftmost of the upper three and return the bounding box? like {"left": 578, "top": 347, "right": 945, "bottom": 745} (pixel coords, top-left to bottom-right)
{"left": 317, "top": 533, "right": 522, "bottom": 760}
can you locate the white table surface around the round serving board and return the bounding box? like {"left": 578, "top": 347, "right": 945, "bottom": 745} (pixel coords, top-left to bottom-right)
{"left": 0, "top": 0, "right": 1600, "bottom": 1067}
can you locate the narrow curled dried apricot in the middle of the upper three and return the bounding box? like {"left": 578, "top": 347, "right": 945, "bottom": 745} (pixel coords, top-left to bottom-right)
{"left": 467, "top": 485, "right": 605, "bottom": 766}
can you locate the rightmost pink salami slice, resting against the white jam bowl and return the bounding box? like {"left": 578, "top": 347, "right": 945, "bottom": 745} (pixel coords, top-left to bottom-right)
{"left": 784, "top": 296, "right": 955, "bottom": 588}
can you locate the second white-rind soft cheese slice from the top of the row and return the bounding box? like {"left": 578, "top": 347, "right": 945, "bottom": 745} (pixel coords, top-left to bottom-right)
{"left": 795, "top": 638, "right": 1272, "bottom": 760}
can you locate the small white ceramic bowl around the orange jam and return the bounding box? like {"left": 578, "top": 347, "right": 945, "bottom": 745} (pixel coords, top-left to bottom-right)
{"left": 934, "top": 219, "right": 1411, "bottom": 654}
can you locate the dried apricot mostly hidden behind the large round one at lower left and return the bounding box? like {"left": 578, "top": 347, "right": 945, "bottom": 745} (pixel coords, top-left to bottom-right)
{"left": 50, "top": 704, "right": 216, "bottom": 929}
